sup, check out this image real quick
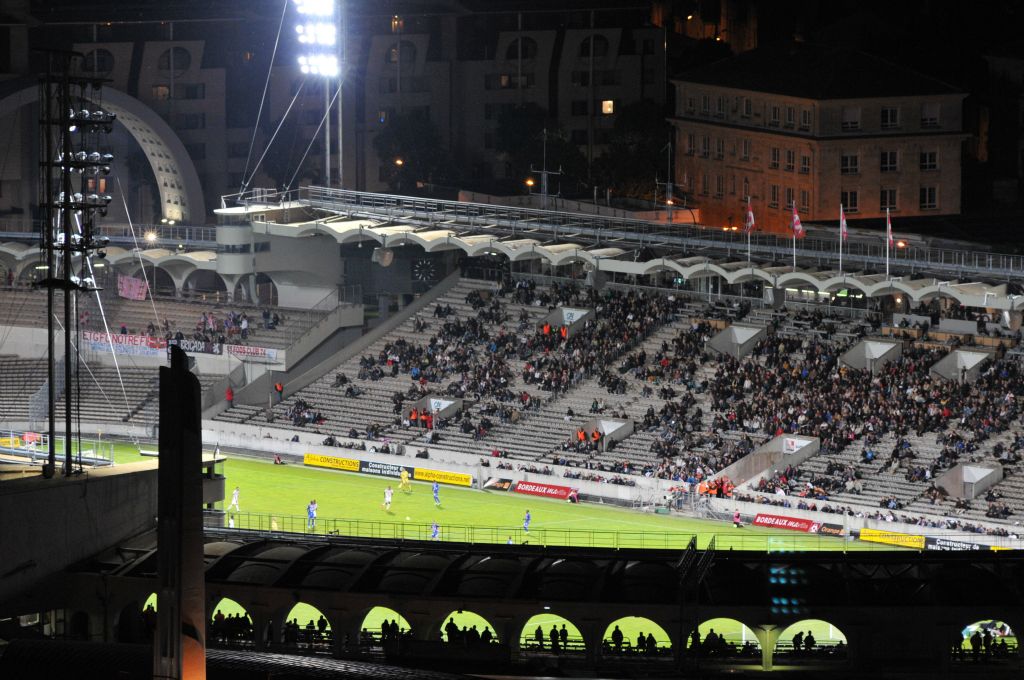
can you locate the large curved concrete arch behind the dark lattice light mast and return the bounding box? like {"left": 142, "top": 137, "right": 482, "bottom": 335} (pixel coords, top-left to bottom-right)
{"left": 0, "top": 83, "right": 206, "bottom": 223}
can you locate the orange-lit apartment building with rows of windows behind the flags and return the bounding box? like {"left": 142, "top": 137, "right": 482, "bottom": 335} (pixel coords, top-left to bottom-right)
{"left": 672, "top": 42, "right": 966, "bottom": 231}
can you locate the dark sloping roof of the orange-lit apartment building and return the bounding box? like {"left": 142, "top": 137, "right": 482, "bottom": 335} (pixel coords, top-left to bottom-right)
{"left": 674, "top": 41, "right": 961, "bottom": 99}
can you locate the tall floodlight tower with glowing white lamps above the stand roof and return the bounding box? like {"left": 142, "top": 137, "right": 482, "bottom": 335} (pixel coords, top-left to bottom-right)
{"left": 295, "top": 0, "right": 341, "bottom": 186}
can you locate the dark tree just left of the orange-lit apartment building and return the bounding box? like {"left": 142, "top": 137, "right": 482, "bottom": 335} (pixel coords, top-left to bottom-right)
{"left": 594, "top": 99, "right": 672, "bottom": 199}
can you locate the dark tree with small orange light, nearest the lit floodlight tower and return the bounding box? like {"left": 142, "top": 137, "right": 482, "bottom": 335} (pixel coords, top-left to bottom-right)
{"left": 374, "top": 112, "right": 448, "bottom": 192}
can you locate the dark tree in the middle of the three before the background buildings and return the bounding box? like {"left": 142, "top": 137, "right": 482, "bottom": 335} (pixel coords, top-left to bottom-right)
{"left": 495, "top": 103, "right": 587, "bottom": 194}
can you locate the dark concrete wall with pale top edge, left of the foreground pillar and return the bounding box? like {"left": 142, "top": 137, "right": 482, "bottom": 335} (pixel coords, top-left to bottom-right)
{"left": 0, "top": 461, "right": 157, "bottom": 615}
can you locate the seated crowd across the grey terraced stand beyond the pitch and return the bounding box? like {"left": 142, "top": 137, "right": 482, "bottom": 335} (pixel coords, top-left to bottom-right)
{"left": 205, "top": 281, "right": 1022, "bottom": 530}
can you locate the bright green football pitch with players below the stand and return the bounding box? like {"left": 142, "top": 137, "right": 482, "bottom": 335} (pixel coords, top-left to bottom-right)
{"left": 115, "top": 444, "right": 893, "bottom": 552}
